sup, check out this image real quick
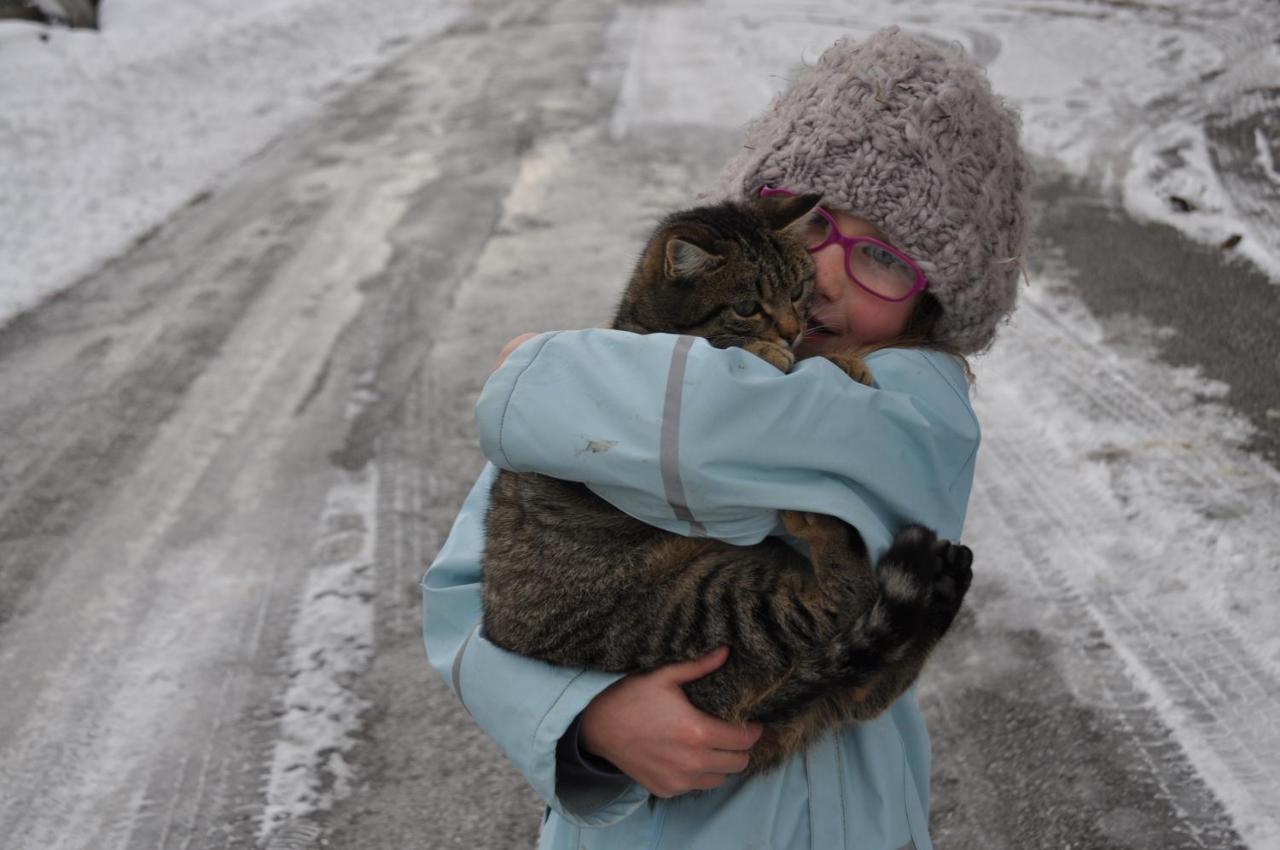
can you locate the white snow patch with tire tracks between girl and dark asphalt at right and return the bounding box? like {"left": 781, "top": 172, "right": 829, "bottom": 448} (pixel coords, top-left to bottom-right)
{"left": 975, "top": 249, "right": 1280, "bottom": 846}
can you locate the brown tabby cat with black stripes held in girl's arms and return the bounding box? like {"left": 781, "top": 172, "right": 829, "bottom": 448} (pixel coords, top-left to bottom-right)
{"left": 483, "top": 195, "right": 972, "bottom": 773}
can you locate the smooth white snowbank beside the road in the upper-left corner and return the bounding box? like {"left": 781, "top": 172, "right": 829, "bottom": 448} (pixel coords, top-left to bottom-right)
{"left": 0, "top": 0, "right": 458, "bottom": 323}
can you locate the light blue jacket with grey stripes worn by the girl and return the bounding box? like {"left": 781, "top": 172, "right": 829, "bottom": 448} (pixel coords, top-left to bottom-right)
{"left": 422, "top": 330, "right": 978, "bottom": 850}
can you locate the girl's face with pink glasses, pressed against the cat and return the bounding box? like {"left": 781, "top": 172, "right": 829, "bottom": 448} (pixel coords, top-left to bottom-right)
{"left": 796, "top": 210, "right": 922, "bottom": 358}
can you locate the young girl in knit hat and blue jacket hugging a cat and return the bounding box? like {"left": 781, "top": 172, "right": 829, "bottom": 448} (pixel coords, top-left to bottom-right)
{"left": 424, "top": 28, "right": 1030, "bottom": 850}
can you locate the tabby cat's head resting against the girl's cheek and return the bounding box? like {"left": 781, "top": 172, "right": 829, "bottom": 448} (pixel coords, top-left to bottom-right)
{"left": 613, "top": 195, "right": 822, "bottom": 348}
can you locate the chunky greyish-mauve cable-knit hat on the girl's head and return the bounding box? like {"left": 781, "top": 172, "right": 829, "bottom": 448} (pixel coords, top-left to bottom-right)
{"left": 719, "top": 27, "right": 1032, "bottom": 353}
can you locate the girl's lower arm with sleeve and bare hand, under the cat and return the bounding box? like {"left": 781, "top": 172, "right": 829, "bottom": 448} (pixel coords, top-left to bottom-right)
{"left": 422, "top": 466, "right": 760, "bottom": 827}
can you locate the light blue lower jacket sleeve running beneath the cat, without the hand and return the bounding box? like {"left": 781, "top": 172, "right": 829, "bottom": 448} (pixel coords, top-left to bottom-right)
{"left": 422, "top": 466, "right": 649, "bottom": 827}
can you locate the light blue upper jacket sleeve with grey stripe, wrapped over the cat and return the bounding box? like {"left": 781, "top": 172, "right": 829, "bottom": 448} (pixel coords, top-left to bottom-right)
{"left": 476, "top": 330, "right": 979, "bottom": 554}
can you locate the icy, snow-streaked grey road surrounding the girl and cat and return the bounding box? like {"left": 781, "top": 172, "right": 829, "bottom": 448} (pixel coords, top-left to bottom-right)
{"left": 0, "top": 0, "right": 1280, "bottom": 850}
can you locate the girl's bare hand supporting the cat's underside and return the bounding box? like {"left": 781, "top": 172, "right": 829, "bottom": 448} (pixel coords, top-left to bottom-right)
{"left": 581, "top": 646, "right": 763, "bottom": 798}
